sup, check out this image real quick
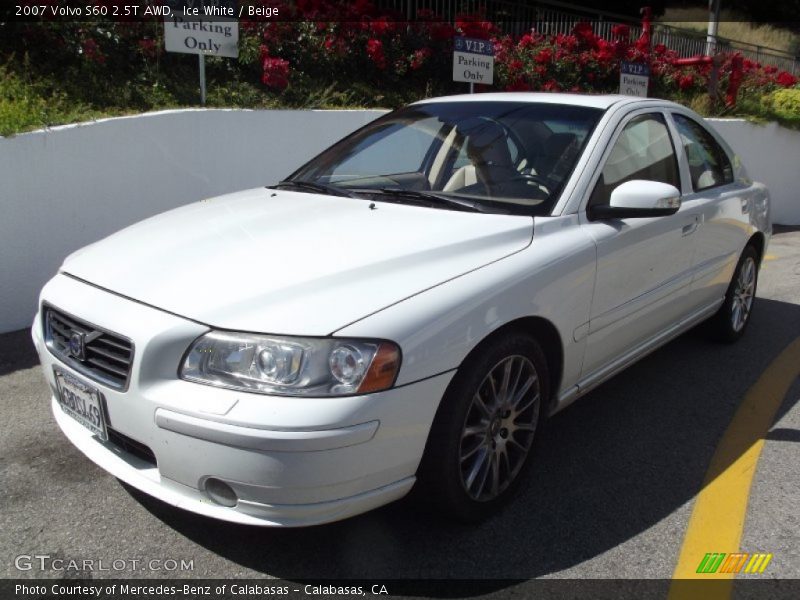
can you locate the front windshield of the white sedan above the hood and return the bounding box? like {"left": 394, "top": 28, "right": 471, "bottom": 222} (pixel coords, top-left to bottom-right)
{"left": 289, "top": 101, "right": 602, "bottom": 215}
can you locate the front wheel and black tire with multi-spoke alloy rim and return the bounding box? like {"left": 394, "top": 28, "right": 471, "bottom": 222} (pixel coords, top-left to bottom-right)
{"left": 418, "top": 333, "right": 549, "bottom": 522}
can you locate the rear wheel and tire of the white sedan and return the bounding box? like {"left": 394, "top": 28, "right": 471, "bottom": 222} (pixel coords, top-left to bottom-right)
{"left": 707, "top": 246, "right": 758, "bottom": 343}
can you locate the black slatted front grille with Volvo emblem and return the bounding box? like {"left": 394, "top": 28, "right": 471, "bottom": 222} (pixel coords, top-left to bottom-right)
{"left": 44, "top": 307, "right": 133, "bottom": 390}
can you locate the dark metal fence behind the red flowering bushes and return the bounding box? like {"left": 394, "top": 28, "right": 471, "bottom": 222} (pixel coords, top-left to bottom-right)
{"left": 378, "top": 0, "right": 800, "bottom": 75}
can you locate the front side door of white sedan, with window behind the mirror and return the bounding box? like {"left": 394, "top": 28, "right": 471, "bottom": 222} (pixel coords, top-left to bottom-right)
{"left": 582, "top": 109, "right": 699, "bottom": 378}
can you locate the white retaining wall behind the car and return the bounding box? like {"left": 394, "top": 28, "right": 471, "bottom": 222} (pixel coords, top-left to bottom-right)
{"left": 0, "top": 110, "right": 800, "bottom": 332}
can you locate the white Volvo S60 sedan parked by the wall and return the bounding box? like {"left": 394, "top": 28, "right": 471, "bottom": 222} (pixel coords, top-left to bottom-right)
{"left": 32, "top": 93, "right": 771, "bottom": 526}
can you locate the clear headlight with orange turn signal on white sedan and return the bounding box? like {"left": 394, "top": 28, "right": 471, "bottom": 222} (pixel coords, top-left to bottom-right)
{"left": 180, "top": 332, "right": 400, "bottom": 396}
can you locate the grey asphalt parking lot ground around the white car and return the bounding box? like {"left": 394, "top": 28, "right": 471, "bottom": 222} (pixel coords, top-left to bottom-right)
{"left": 0, "top": 229, "right": 800, "bottom": 595}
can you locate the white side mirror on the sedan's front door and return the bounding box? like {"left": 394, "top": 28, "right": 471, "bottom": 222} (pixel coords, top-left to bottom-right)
{"left": 589, "top": 179, "right": 681, "bottom": 221}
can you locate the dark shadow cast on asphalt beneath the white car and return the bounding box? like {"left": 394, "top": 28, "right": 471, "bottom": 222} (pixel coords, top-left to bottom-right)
{"left": 126, "top": 299, "right": 800, "bottom": 591}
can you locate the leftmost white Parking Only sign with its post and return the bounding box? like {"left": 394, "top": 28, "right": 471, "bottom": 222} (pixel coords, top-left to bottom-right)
{"left": 164, "top": 0, "right": 239, "bottom": 106}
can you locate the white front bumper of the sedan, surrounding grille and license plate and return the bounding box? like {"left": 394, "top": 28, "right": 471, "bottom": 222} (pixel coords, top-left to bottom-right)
{"left": 32, "top": 275, "right": 452, "bottom": 526}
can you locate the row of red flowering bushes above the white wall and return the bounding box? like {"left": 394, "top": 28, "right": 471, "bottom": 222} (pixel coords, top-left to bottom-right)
{"left": 18, "top": 0, "right": 797, "bottom": 109}
